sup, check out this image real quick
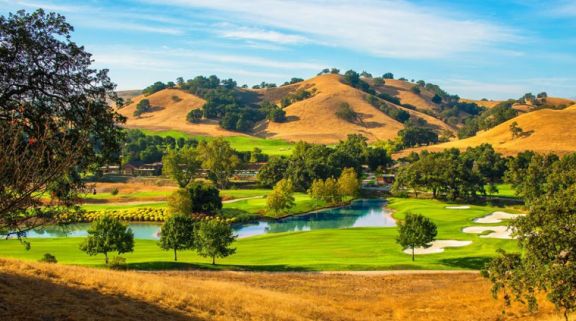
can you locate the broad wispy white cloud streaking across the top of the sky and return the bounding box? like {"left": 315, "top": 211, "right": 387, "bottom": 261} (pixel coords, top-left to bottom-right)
{"left": 143, "top": 0, "right": 518, "bottom": 58}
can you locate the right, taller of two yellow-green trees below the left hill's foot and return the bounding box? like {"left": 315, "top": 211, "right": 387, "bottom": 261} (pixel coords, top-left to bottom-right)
{"left": 197, "top": 138, "right": 240, "bottom": 189}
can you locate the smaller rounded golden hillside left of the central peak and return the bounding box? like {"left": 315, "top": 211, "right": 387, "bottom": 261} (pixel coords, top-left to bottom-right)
{"left": 118, "top": 89, "right": 244, "bottom": 136}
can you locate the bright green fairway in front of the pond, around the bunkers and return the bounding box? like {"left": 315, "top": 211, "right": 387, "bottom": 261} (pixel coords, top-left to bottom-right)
{"left": 0, "top": 199, "right": 517, "bottom": 271}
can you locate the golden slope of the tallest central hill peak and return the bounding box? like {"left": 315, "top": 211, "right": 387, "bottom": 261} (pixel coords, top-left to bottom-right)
{"left": 255, "top": 74, "right": 404, "bottom": 144}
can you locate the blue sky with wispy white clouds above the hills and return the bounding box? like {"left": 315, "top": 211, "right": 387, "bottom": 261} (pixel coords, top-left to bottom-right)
{"left": 0, "top": 0, "right": 576, "bottom": 99}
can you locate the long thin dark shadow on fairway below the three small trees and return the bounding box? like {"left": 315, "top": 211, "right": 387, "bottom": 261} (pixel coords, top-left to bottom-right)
{"left": 126, "top": 261, "right": 314, "bottom": 272}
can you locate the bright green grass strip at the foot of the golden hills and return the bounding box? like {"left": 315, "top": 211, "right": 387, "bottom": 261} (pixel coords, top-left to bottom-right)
{"left": 142, "top": 129, "right": 294, "bottom": 155}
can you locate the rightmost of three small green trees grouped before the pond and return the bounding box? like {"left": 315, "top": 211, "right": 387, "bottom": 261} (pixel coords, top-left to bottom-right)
{"left": 194, "top": 219, "right": 236, "bottom": 264}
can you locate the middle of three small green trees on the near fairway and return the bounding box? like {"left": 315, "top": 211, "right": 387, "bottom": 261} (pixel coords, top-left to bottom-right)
{"left": 158, "top": 214, "right": 195, "bottom": 261}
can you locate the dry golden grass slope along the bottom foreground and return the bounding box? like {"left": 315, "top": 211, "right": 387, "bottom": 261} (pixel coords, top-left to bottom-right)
{"left": 0, "top": 259, "right": 560, "bottom": 321}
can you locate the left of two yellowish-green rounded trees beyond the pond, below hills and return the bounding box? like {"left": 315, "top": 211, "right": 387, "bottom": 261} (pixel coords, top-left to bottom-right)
{"left": 162, "top": 147, "right": 201, "bottom": 188}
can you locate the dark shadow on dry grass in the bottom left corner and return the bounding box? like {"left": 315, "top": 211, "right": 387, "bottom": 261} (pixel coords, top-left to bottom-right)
{"left": 0, "top": 270, "right": 196, "bottom": 321}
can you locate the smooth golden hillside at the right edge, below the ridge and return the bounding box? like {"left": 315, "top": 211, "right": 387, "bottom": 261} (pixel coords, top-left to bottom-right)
{"left": 404, "top": 105, "right": 576, "bottom": 155}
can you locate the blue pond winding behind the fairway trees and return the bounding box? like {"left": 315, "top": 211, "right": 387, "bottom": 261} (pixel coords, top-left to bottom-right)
{"left": 18, "top": 200, "right": 396, "bottom": 240}
